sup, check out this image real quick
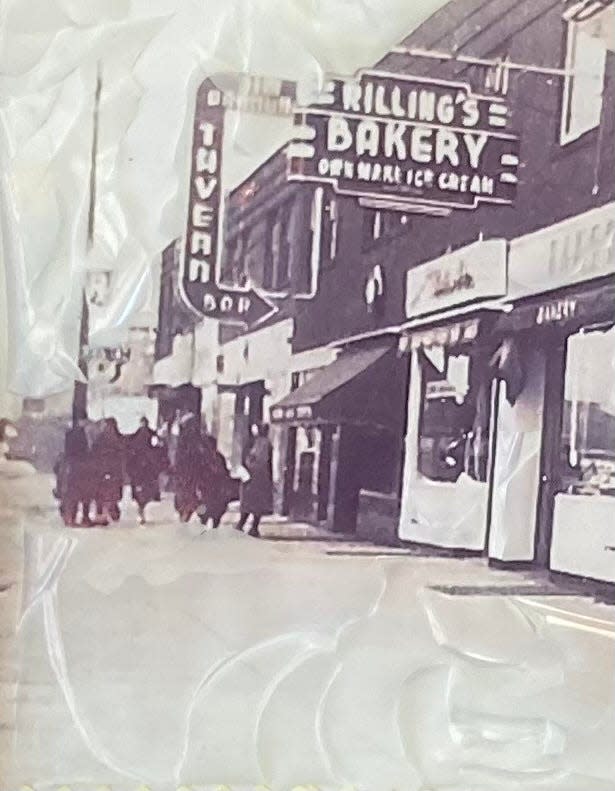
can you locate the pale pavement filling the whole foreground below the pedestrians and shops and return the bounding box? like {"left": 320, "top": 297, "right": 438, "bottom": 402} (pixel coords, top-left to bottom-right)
{"left": 0, "top": 476, "right": 615, "bottom": 791}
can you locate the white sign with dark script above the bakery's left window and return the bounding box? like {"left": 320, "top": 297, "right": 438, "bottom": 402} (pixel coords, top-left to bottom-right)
{"left": 406, "top": 239, "right": 508, "bottom": 319}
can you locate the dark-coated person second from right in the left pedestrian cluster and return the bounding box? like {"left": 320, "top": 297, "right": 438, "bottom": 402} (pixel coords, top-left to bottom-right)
{"left": 90, "top": 417, "right": 125, "bottom": 526}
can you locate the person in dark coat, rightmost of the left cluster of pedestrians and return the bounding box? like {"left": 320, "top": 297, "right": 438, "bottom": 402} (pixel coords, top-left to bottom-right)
{"left": 126, "top": 417, "right": 166, "bottom": 525}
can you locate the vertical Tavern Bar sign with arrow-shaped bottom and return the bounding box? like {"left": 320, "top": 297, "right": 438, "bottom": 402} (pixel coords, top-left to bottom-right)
{"left": 179, "top": 74, "right": 295, "bottom": 325}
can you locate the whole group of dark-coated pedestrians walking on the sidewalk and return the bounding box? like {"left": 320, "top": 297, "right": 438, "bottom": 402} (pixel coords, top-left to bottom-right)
{"left": 55, "top": 414, "right": 273, "bottom": 536}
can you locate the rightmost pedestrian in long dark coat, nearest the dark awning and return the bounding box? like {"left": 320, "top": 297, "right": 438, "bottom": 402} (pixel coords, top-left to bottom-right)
{"left": 237, "top": 423, "right": 273, "bottom": 537}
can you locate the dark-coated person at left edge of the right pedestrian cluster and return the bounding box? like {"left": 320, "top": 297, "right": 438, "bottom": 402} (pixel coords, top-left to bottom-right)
{"left": 173, "top": 412, "right": 202, "bottom": 522}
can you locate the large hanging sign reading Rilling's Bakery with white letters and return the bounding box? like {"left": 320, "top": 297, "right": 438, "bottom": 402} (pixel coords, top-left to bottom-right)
{"left": 289, "top": 71, "right": 519, "bottom": 209}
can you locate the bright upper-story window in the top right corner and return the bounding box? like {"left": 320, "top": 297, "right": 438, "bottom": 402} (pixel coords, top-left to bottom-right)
{"left": 560, "top": 5, "right": 615, "bottom": 144}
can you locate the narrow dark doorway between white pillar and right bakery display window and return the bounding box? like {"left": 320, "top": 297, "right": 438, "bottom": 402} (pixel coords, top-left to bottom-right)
{"left": 534, "top": 336, "right": 566, "bottom": 568}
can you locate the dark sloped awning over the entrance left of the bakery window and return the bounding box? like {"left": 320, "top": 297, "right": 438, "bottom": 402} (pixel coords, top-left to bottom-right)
{"left": 271, "top": 338, "right": 408, "bottom": 428}
